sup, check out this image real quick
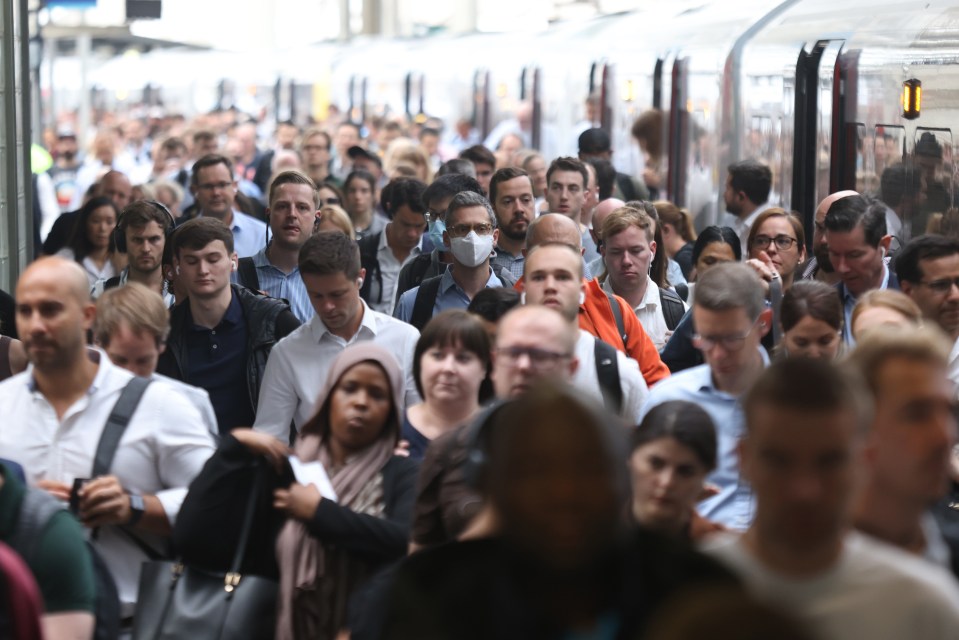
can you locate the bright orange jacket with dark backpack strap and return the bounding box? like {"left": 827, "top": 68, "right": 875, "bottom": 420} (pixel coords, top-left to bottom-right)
{"left": 516, "top": 278, "right": 669, "bottom": 387}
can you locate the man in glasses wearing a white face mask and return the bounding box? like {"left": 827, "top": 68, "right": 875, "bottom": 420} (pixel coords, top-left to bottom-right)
{"left": 393, "top": 191, "right": 506, "bottom": 329}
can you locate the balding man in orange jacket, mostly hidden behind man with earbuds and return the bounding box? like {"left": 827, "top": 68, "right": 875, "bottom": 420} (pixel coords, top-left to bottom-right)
{"left": 516, "top": 213, "right": 669, "bottom": 387}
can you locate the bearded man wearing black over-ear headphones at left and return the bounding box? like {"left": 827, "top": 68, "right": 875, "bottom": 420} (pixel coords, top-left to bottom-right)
{"left": 100, "top": 200, "right": 173, "bottom": 307}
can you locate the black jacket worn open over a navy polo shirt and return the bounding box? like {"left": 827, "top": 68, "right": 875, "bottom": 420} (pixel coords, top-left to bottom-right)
{"left": 157, "top": 284, "right": 300, "bottom": 411}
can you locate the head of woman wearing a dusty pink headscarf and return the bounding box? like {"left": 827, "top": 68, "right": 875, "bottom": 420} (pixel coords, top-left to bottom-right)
{"left": 300, "top": 341, "right": 403, "bottom": 452}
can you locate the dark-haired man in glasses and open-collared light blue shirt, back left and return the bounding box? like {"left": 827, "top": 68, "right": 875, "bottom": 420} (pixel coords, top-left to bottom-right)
{"left": 190, "top": 154, "right": 267, "bottom": 258}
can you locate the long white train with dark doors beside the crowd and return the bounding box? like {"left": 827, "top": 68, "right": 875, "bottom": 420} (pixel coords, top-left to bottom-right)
{"left": 56, "top": 0, "right": 959, "bottom": 238}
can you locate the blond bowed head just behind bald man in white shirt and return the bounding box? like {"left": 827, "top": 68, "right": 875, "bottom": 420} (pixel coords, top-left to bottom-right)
{"left": 93, "top": 282, "right": 170, "bottom": 378}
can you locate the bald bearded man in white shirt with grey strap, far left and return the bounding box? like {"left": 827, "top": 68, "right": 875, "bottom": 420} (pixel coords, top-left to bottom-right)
{"left": 0, "top": 257, "right": 214, "bottom": 618}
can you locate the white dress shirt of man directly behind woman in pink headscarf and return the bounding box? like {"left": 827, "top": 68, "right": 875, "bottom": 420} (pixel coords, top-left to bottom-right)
{"left": 253, "top": 299, "right": 420, "bottom": 442}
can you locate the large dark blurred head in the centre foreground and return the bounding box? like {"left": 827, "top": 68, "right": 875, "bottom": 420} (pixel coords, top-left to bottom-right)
{"left": 474, "top": 381, "right": 628, "bottom": 575}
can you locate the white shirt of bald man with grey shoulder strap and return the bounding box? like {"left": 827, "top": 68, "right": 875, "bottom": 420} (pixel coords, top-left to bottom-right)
{"left": 0, "top": 352, "right": 214, "bottom": 616}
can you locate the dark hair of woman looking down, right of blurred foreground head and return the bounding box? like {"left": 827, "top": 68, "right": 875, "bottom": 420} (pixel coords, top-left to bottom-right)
{"left": 629, "top": 400, "right": 717, "bottom": 471}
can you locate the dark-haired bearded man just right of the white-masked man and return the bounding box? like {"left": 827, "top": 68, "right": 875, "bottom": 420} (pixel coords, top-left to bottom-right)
{"left": 489, "top": 167, "right": 535, "bottom": 279}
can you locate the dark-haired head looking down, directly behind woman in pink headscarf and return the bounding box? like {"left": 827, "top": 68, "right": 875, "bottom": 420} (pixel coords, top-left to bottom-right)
{"left": 298, "top": 231, "right": 366, "bottom": 333}
